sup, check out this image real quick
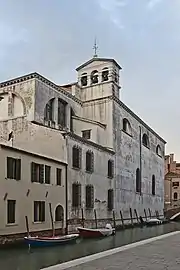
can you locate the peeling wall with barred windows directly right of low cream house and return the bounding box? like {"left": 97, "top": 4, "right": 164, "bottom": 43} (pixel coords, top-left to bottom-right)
{"left": 67, "top": 138, "right": 114, "bottom": 219}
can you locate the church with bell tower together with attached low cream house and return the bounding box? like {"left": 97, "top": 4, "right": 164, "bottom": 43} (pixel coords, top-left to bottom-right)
{"left": 0, "top": 51, "right": 166, "bottom": 234}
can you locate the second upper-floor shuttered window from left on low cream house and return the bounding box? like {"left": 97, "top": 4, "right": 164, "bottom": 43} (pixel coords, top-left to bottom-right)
{"left": 31, "top": 162, "right": 44, "bottom": 183}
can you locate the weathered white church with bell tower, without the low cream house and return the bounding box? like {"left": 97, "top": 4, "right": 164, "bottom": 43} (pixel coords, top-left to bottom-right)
{"left": 0, "top": 55, "right": 165, "bottom": 236}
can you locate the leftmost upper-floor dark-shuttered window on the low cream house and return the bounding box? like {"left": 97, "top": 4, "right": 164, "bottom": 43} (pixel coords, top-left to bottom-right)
{"left": 7, "top": 157, "right": 21, "bottom": 180}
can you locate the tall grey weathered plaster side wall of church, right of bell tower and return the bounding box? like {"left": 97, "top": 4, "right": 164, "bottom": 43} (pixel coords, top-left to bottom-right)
{"left": 113, "top": 103, "right": 165, "bottom": 216}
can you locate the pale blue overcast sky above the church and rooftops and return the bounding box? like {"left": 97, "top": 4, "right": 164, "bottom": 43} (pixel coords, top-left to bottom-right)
{"left": 0, "top": 0, "right": 180, "bottom": 161}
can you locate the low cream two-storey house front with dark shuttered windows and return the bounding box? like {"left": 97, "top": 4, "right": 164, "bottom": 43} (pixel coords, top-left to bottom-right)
{"left": 0, "top": 144, "right": 66, "bottom": 235}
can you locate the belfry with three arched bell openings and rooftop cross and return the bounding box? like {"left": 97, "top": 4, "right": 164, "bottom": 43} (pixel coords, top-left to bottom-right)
{"left": 76, "top": 53, "right": 121, "bottom": 101}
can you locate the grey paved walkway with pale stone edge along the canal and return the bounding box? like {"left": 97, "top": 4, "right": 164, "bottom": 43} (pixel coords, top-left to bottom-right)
{"left": 41, "top": 232, "right": 180, "bottom": 270}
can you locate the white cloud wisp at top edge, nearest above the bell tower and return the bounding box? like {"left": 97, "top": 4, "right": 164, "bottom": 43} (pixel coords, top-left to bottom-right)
{"left": 98, "top": 0, "right": 127, "bottom": 29}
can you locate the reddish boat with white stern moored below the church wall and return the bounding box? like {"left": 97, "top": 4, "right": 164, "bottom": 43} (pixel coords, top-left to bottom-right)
{"left": 77, "top": 224, "right": 115, "bottom": 238}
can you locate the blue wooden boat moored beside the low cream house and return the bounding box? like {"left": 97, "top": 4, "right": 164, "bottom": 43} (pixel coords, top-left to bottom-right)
{"left": 24, "top": 234, "right": 79, "bottom": 247}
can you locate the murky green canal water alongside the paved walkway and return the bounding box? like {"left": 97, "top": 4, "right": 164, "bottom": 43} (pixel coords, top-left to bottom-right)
{"left": 0, "top": 223, "right": 180, "bottom": 270}
